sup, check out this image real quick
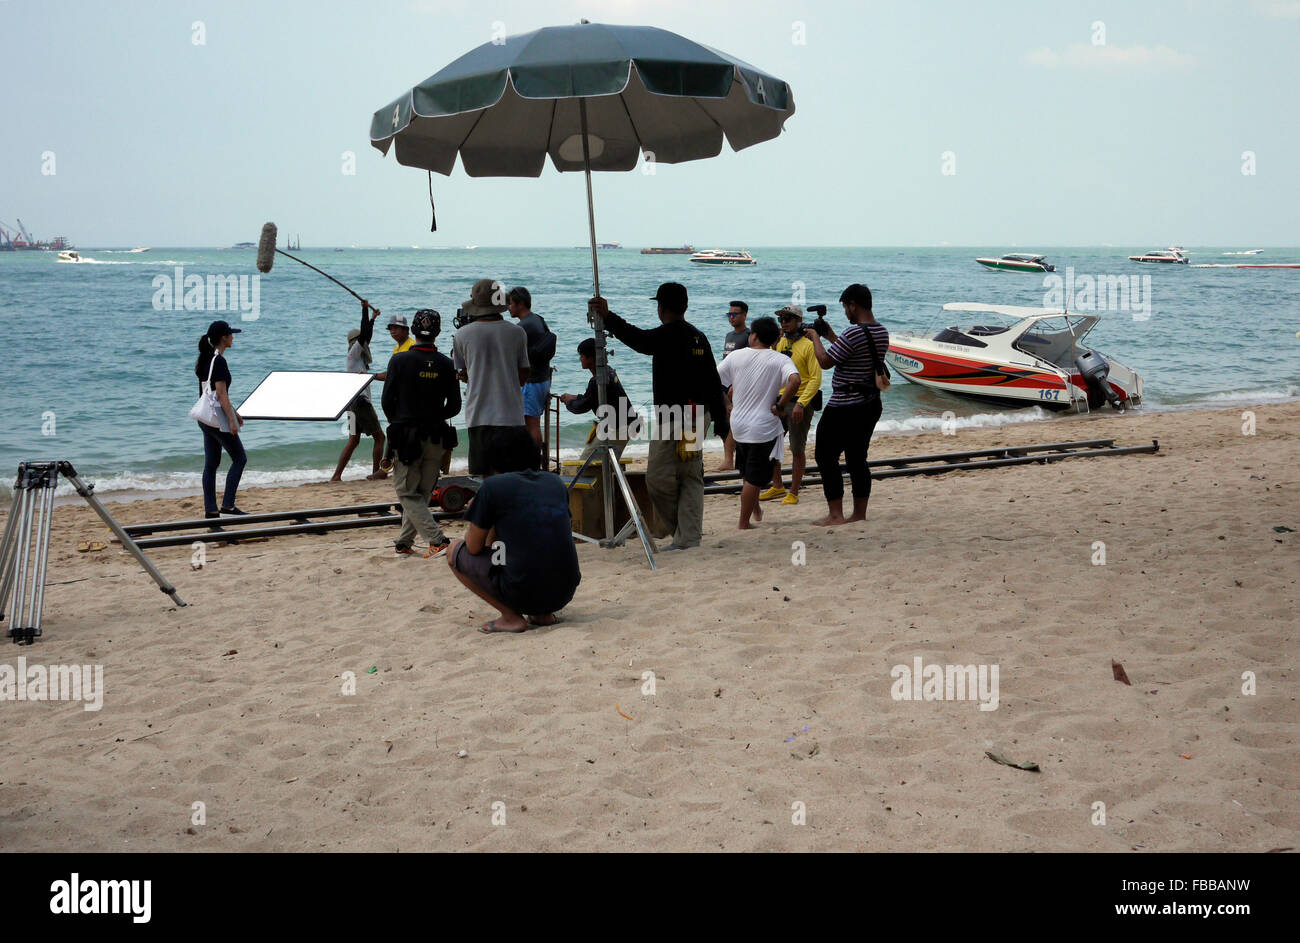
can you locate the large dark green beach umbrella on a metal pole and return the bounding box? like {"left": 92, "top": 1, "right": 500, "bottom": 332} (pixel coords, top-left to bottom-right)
{"left": 371, "top": 21, "right": 794, "bottom": 551}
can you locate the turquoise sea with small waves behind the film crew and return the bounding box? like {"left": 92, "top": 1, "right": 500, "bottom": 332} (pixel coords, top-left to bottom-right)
{"left": 0, "top": 246, "right": 1300, "bottom": 499}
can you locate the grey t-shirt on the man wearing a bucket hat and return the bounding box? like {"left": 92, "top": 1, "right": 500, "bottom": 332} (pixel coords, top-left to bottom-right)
{"left": 451, "top": 320, "right": 528, "bottom": 428}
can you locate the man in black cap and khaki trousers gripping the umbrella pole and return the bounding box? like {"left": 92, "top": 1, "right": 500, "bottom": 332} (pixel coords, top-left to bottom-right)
{"left": 589, "top": 282, "right": 729, "bottom": 550}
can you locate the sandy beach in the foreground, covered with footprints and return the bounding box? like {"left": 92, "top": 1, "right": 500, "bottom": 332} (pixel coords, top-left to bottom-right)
{"left": 0, "top": 403, "right": 1300, "bottom": 852}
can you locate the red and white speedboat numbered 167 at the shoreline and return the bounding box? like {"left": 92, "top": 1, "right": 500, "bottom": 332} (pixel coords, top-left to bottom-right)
{"left": 885, "top": 302, "right": 1143, "bottom": 412}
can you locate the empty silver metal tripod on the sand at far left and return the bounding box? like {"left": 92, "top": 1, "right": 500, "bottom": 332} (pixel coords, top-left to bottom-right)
{"left": 0, "top": 462, "right": 185, "bottom": 645}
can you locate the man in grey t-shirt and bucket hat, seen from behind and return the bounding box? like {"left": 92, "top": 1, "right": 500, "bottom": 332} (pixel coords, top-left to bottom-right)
{"left": 451, "top": 278, "right": 530, "bottom": 475}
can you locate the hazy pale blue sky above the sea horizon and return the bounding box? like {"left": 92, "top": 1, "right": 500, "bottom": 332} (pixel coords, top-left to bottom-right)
{"left": 0, "top": 0, "right": 1300, "bottom": 248}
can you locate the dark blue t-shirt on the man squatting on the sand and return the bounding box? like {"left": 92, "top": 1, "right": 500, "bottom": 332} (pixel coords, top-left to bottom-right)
{"left": 467, "top": 471, "right": 582, "bottom": 615}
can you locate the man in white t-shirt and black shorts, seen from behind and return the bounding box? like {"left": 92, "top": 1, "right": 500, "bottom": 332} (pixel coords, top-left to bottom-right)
{"left": 718, "top": 317, "right": 800, "bottom": 531}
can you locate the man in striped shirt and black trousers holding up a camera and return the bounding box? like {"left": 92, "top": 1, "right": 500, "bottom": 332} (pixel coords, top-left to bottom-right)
{"left": 805, "top": 282, "right": 889, "bottom": 525}
